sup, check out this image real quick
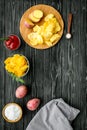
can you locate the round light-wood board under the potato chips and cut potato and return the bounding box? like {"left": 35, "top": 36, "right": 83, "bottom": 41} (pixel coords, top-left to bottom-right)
{"left": 20, "top": 4, "right": 64, "bottom": 49}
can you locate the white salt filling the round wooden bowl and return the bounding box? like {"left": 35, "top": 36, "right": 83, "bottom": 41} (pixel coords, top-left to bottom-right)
{"left": 5, "top": 104, "right": 21, "bottom": 121}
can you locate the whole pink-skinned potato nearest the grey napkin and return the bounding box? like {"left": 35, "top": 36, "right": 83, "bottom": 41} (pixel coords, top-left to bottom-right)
{"left": 27, "top": 98, "right": 40, "bottom": 111}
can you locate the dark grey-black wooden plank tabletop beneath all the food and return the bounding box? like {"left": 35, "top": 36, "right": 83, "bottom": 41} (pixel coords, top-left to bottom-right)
{"left": 0, "top": 0, "right": 87, "bottom": 130}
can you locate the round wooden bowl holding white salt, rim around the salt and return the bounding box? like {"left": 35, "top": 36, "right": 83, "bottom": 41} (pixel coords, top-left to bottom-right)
{"left": 2, "top": 103, "right": 23, "bottom": 123}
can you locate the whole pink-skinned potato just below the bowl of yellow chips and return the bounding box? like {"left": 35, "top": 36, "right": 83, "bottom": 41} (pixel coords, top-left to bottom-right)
{"left": 15, "top": 85, "right": 28, "bottom": 98}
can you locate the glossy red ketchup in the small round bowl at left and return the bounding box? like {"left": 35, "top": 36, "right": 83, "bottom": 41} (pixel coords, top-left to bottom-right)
{"left": 5, "top": 34, "right": 21, "bottom": 50}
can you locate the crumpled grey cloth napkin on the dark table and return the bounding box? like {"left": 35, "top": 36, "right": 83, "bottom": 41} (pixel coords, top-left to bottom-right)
{"left": 26, "top": 98, "right": 80, "bottom": 130}
